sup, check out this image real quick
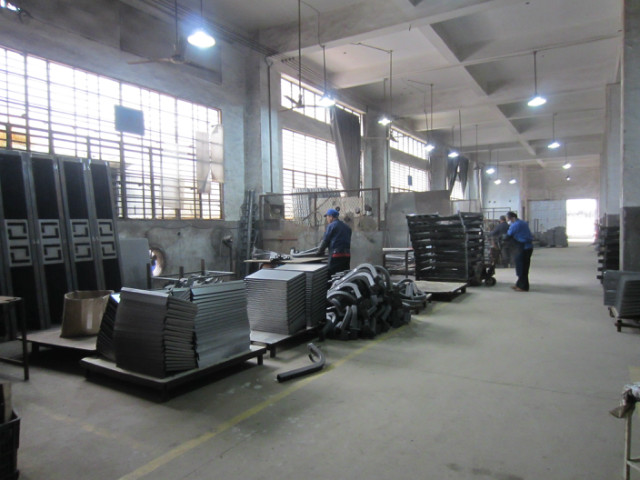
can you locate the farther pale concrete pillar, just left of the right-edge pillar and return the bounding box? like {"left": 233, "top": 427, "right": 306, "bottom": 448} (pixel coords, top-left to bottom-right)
{"left": 600, "top": 84, "right": 622, "bottom": 217}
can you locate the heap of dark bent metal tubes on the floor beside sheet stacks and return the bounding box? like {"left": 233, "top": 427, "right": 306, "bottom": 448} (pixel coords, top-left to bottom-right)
{"left": 322, "top": 263, "right": 428, "bottom": 340}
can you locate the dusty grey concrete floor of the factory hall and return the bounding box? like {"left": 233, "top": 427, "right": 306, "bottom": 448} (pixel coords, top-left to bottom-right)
{"left": 0, "top": 245, "right": 640, "bottom": 480}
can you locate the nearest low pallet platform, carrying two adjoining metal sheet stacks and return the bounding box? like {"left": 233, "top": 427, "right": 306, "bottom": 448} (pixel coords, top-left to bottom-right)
{"left": 80, "top": 345, "right": 267, "bottom": 400}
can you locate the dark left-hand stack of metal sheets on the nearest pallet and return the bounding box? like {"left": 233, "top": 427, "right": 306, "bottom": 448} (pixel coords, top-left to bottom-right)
{"left": 114, "top": 288, "right": 197, "bottom": 378}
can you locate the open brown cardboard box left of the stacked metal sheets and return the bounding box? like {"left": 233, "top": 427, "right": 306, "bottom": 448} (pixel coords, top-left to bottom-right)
{"left": 60, "top": 290, "right": 113, "bottom": 337}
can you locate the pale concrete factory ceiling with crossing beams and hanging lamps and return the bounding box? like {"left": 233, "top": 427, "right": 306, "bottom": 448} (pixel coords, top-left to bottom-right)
{"left": 128, "top": 0, "right": 622, "bottom": 168}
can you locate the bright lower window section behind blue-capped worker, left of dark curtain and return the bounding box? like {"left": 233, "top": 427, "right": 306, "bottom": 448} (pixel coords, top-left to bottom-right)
{"left": 282, "top": 129, "right": 342, "bottom": 218}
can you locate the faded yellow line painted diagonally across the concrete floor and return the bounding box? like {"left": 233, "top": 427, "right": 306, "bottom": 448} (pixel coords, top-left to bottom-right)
{"left": 119, "top": 325, "right": 416, "bottom": 480}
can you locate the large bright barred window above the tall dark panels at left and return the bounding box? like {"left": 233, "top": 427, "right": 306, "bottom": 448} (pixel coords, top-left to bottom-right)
{"left": 0, "top": 44, "right": 222, "bottom": 219}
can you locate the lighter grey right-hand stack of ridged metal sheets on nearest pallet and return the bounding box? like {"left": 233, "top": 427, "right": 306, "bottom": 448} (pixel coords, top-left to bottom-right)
{"left": 191, "top": 280, "right": 251, "bottom": 367}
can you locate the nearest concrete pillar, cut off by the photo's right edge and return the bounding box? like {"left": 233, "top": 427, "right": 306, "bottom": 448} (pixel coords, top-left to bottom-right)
{"left": 620, "top": 0, "right": 640, "bottom": 271}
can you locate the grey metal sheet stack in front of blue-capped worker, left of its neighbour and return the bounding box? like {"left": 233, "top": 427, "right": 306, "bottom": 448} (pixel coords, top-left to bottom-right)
{"left": 244, "top": 268, "right": 307, "bottom": 335}
